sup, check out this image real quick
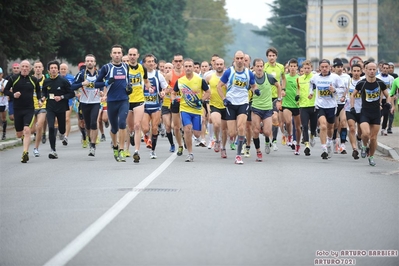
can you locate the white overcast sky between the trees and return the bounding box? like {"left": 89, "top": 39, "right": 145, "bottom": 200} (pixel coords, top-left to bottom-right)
{"left": 226, "top": 0, "right": 273, "bottom": 28}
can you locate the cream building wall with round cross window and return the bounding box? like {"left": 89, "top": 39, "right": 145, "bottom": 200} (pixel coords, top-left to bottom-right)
{"left": 306, "top": 0, "right": 378, "bottom": 61}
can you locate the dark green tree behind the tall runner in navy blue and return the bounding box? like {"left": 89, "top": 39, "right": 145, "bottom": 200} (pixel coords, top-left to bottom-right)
{"left": 58, "top": 0, "right": 150, "bottom": 65}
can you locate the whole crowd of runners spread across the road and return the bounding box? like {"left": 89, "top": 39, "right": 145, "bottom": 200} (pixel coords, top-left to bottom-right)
{"left": 0, "top": 45, "right": 398, "bottom": 166}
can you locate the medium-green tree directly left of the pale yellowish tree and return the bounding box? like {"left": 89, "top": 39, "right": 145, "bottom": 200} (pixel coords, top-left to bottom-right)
{"left": 135, "top": 0, "right": 187, "bottom": 61}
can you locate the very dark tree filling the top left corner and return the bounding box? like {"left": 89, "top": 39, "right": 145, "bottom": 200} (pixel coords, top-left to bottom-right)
{"left": 0, "top": 0, "right": 72, "bottom": 71}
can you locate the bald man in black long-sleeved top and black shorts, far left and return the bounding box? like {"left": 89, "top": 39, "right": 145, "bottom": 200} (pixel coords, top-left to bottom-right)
{"left": 4, "top": 60, "right": 42, "bottom": 163}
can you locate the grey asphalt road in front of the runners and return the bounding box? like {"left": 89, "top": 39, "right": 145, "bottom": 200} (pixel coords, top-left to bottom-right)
{"left": 0, "top": 128, "right": 399, "bottom": 265}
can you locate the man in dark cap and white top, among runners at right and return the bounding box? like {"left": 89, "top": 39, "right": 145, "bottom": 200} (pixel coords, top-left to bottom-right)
{"left": 333, "top": 58, "right": 350, "bottom": 154}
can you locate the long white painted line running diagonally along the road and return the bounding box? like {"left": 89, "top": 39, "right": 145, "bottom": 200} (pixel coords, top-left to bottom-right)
{"left": 44, "top": 153, "right": 177, "bottom": 266}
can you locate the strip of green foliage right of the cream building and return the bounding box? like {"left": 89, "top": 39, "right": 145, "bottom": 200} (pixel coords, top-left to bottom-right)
{"left": 378, "top": 0, "right": 399, "bottom": 62}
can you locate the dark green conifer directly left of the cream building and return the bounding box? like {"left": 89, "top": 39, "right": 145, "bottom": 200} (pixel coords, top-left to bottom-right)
{"left": 254, "top": 0, "right": 307, "bottom": 62}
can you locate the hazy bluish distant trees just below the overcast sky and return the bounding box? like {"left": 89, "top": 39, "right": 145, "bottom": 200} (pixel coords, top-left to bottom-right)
{"left": 225, "top": 19, "right": 270, "bottom": 64}
